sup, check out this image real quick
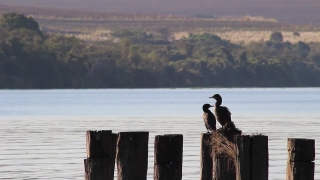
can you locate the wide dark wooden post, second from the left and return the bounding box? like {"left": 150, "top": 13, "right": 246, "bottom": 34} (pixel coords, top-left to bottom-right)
{"left": 116, "top": 132, "right": 149, "bottom": 180}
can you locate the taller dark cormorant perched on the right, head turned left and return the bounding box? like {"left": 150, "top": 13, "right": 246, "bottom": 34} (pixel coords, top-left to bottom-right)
{"left": 209, "top": 94, "right": 234, "bottom": 128}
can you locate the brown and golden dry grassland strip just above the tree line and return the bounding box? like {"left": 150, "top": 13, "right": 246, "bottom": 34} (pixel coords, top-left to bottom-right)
{"left": 0, "top": 5, "right": 320, "bottom": 44}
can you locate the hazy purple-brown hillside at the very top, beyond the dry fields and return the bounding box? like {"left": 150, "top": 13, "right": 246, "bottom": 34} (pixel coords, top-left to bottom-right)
{"left": 0, "top": 0, "right": 320, "bottom": 26}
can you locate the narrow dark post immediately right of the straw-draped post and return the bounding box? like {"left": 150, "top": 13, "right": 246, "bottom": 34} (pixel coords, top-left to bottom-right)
{"left": 234, "top": 135, "right": 251, "bottom": 180}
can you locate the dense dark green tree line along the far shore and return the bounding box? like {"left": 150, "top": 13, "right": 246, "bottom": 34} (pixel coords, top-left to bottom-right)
{"left": 0, "top": 13, "right": 320, "bottom": 89}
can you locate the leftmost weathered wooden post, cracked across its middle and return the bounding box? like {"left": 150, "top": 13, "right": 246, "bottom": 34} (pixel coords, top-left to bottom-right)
{"left": 84, "top": 131, "right": 116, "bottom": 180}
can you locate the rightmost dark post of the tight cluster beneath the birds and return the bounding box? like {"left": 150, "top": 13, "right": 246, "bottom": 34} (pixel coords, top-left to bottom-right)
{"left": 251, "top": 135, "right": 269, "bottom": 180}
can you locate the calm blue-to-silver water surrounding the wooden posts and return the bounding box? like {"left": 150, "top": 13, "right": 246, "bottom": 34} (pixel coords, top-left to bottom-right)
{"left": 0, "top": 88, "right": 320, "bottom": 180}
